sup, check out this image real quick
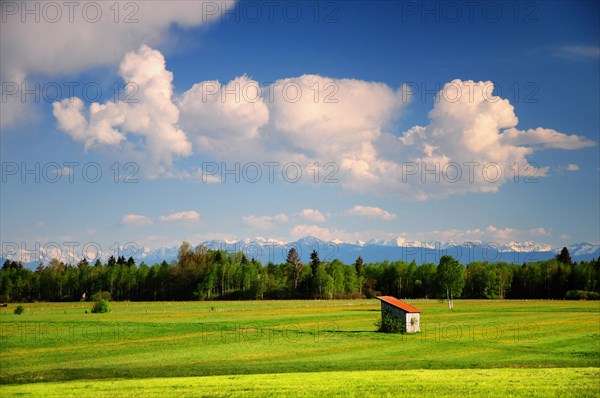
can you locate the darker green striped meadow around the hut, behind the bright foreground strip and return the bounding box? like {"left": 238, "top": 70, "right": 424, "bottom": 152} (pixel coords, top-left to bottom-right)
{"left": 0, "top": 300, "right": 600, "bottom": 384}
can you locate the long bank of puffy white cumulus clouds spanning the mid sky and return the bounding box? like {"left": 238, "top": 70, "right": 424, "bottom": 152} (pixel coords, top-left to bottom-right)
{"left": 55, "top": 46, "right": 596, "bottom": 199}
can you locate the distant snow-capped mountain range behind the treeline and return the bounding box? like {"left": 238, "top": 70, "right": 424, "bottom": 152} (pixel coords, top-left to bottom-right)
{"left": 0, "top": 236, "right": 600, "bottom": 269}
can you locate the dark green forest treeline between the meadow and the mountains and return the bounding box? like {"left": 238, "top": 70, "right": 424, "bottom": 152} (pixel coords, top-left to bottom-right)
{"left": 0, "top": 242, "right": 600, "bottom": 302}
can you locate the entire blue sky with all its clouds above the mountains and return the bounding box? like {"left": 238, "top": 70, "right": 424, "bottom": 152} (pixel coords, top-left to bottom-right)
{"left": 0, "top": 0, "right": 600, "bottom": 262}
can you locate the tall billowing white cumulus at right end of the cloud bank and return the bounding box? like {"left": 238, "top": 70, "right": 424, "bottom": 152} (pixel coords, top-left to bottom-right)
{"left": 384, "top": 80, "right": 533, "bottom": 199}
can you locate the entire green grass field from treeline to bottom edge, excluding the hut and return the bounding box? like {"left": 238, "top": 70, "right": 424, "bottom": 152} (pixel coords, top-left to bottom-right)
{"left": 0, "top": 300, "right": 600, "bottom": 397}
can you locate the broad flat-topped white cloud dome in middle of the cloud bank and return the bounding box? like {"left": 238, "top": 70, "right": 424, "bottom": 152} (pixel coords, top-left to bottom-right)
{"left": 265, "top": 75, "right": 404, "bottom": 155}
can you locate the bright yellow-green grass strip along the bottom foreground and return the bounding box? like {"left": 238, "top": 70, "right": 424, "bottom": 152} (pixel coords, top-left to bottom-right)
{"left": 0, "top": 368, "right": 600, "bottom": 398}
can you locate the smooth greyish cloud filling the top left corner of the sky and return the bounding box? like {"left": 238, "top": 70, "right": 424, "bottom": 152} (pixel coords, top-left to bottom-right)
{"left": 0, "top": 0, "right": 235, "bottom": 127}
